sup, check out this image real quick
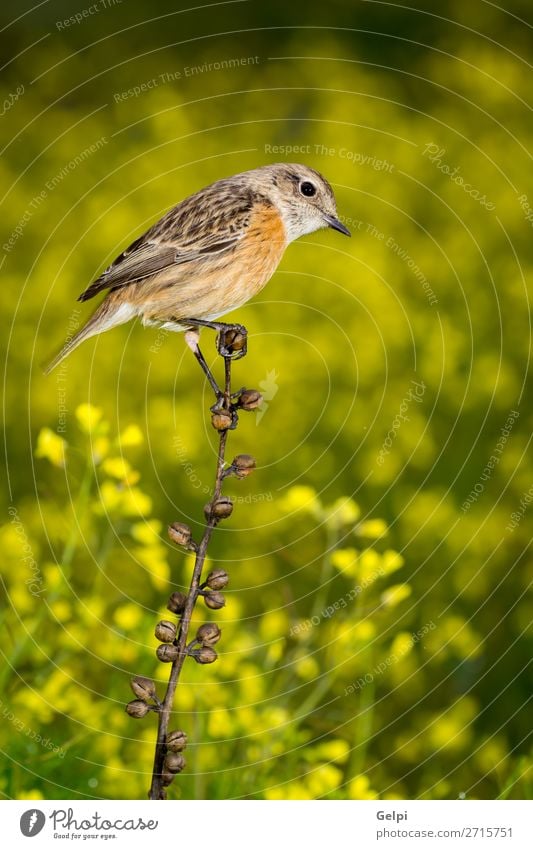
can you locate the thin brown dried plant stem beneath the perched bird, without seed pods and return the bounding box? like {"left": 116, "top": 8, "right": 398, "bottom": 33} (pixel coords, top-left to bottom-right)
{"left": 148, "top": 357, "right": 231, "bottom": 799}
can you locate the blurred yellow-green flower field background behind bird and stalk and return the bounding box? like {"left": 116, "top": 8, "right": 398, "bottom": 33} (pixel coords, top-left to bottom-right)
{"left": 0, "top": 0, "right": 533, "bottom": 799}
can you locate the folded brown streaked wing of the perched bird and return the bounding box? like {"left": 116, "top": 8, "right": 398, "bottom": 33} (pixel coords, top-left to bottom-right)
{"left": 78, "top": 180, "right": 257, "bottom": 301}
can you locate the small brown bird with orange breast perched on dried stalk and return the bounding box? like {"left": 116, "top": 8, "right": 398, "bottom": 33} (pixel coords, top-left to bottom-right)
{"left": 45, "top": 163, "right": 351, "bottom": 374}
